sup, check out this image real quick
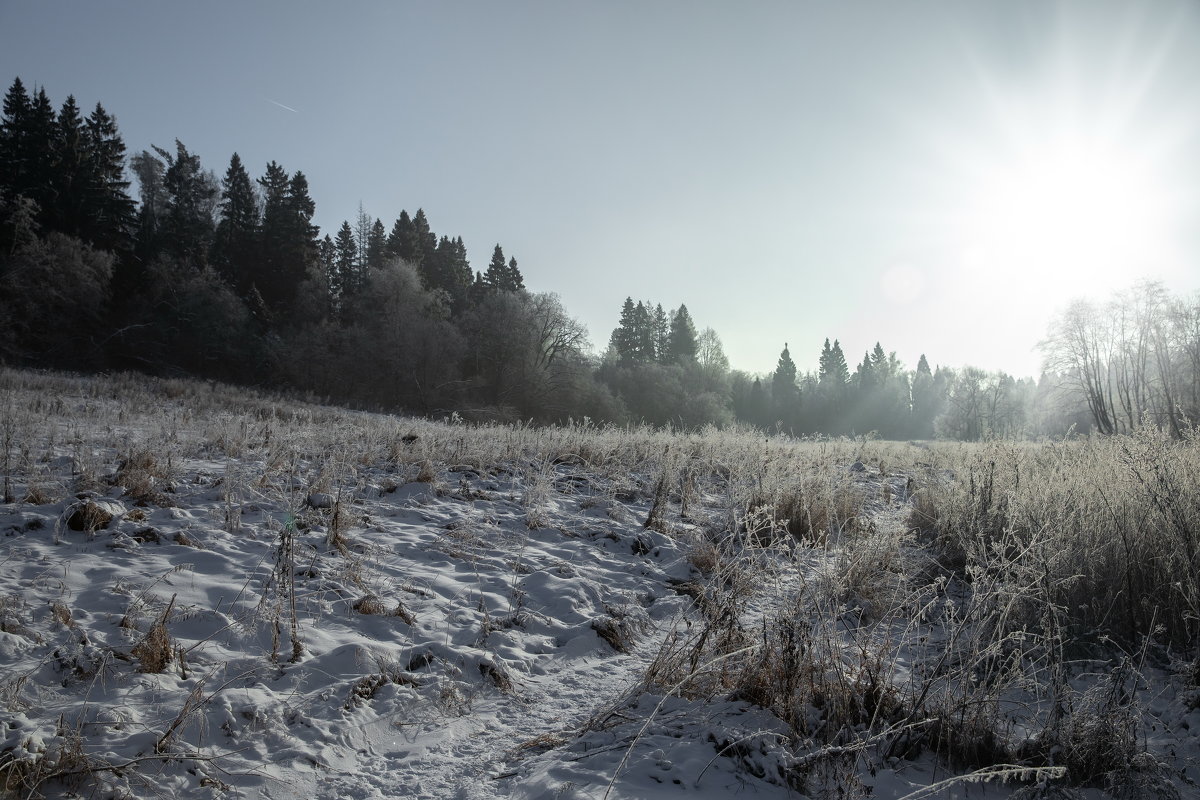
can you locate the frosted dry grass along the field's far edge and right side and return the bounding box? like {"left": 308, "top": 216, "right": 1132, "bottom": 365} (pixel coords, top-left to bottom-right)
{"left": 0, "top": 369, "right": 1200, "bottom": 796}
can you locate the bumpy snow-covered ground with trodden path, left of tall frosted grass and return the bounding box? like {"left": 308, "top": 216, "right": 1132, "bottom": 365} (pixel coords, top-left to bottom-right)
{"left": 0, "top": 371, "right": 1200, "bottom": 800}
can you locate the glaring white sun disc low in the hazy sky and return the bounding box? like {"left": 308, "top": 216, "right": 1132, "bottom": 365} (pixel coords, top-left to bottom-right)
{"left": 961, "top": 132, "right": 1169, "bottom": 291}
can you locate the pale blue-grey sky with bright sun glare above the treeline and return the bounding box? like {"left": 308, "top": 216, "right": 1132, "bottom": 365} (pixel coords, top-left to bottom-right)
{"left": 0, "top": 0, "right": 1200, "bottom": 375}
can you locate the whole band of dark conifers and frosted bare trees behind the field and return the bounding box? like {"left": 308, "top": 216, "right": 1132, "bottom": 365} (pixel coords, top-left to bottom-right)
{"left": 0, "top": 78, "right": 1200, "bottom": 440}
